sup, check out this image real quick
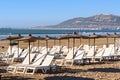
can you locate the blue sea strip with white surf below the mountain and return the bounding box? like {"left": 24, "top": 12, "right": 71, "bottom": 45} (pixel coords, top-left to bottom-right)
{"left": 0, "top": 28, "right": 120, "bottom": 39}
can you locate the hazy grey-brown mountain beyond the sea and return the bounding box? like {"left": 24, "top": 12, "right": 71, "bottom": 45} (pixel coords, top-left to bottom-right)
{"left": 34, "top": 14, "right": 120, "bottom": 30}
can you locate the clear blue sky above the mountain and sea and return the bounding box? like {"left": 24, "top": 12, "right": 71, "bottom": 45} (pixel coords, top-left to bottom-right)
{"left": 0, "top": 0, "right": 120, "bottom": 28}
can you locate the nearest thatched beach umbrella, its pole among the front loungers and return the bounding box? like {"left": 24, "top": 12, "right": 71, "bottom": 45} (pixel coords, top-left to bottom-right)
{"left": 16, "top": 34, "right": 37, "bottom": 64}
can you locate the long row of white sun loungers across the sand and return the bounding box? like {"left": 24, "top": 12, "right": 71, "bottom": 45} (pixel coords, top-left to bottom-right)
{"left": 1, "top": 44, "right": 120, "bottom": 74}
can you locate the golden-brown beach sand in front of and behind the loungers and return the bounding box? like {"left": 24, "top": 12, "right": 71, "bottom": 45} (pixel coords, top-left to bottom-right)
{"left": 0, "top": 38, "right": 120, "bottom": 80}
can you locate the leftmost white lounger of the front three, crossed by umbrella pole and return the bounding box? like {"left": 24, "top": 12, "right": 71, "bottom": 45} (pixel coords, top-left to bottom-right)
{"left": 7, "top": 53, "right": 35, "bottom": 73}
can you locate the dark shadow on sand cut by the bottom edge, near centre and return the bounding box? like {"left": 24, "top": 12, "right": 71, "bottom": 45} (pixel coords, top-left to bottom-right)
{"left": 44, "top": 76, "right": 94, "bottom": 80}
